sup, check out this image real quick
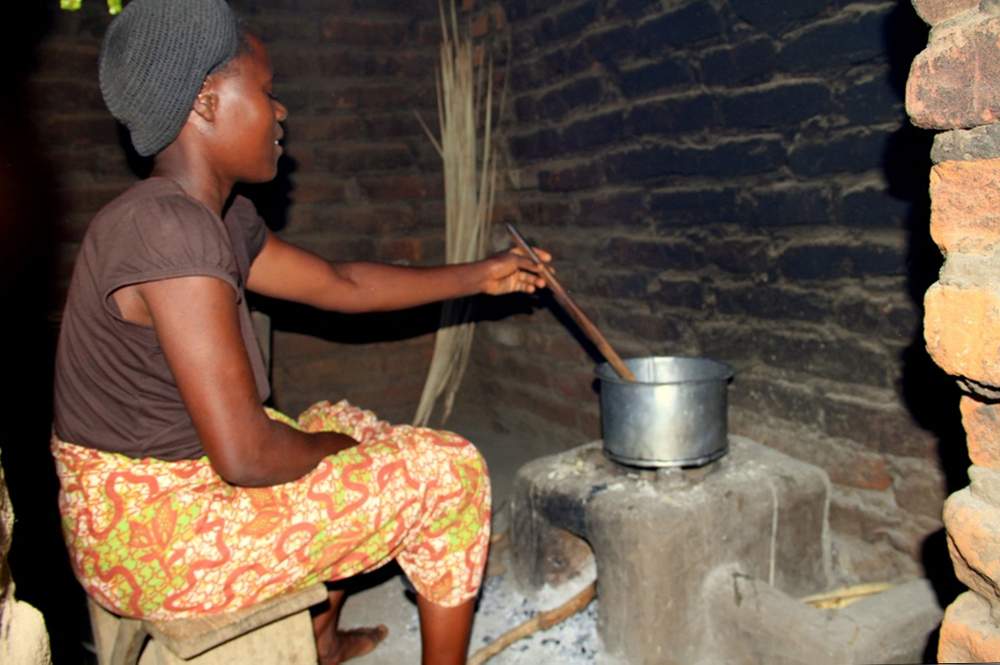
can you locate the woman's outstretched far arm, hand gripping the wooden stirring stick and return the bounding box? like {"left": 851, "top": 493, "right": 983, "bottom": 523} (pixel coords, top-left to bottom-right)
{"left": 247, "top": 232, "right": 550, "bottom": 312}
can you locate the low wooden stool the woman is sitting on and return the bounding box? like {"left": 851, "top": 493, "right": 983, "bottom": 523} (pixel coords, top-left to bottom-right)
{"left": 87, "top": 584, "right": 327, "bottom": 665}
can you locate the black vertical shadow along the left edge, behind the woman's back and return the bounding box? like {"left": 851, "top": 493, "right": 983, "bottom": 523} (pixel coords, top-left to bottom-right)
{"left": 0, "top": 2, "right": 89, "bottom": 665}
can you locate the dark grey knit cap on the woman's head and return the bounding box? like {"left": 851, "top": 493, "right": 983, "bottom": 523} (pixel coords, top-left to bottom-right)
{"left": 99, "top": 0, "right": 240, "bottom": 156}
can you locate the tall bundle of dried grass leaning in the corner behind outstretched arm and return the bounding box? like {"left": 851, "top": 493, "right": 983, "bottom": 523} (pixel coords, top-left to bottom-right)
{"left": 413, "top": 0, "right": 496, "bottom": 425}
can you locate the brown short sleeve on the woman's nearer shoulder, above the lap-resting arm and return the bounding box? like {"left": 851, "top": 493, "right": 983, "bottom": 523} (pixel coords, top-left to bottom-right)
{"left": 98, "top": 195, "right": 242, "bottom": 306}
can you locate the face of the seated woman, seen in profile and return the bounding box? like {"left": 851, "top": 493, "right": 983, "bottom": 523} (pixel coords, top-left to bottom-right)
{"left": 211, "top": 35, "right": 288, "bottom": 182}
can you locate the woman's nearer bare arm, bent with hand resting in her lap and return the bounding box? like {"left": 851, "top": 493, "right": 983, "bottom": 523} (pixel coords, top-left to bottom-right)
{"left": 131, "top": 276, "right": 357, "bottom": 486}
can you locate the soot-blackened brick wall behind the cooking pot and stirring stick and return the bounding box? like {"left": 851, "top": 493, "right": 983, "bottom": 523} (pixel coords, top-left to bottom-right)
{"left": 450, "top": 0, "right": 948, "bottom": 579}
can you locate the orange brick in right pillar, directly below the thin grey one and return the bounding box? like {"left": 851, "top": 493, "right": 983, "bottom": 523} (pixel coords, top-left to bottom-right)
{"left": 930, "top": 159, "right": 1000, "bottom": 256}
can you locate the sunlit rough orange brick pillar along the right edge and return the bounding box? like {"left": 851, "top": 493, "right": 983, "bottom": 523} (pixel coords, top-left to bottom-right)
{"left": 906, "top": 0, "right": 1000, "bottom": 662}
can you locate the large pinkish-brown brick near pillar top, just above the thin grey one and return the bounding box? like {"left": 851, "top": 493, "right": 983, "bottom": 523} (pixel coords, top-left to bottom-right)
{"left": 906, "top": 15, "right": 1000, "bottom": 129}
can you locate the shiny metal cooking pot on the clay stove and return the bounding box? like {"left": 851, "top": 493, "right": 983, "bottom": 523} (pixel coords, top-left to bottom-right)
{"left": 597, "top": 356, "right": 733, "bottom": 467}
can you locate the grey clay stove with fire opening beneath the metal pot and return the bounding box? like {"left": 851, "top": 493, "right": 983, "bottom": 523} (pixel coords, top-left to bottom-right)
{"left": 510, "top": 436, "right": 940, "bottom": 665}
